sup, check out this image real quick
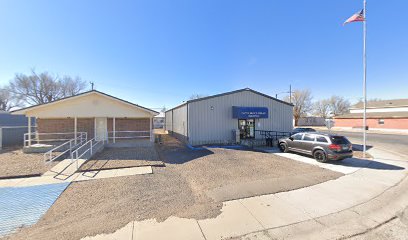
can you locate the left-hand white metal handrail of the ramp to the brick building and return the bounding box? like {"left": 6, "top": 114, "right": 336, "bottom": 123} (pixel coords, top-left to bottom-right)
{"left": 44, "top": 132, "right": 87, "bottom": 163}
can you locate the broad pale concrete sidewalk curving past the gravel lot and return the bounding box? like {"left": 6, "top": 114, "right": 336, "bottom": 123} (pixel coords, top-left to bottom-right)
{"left": 84, "top": 147, "right": 408, "bottom": 240}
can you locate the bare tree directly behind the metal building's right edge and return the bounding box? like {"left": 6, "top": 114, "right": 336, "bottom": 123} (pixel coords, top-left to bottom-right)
{"left": 285, "top": 90, "right": 312, "bottom": 126}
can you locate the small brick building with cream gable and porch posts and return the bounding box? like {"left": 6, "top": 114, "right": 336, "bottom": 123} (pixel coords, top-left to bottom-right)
{"left": 13, "top": 90, "right": 158, "bottom": 145}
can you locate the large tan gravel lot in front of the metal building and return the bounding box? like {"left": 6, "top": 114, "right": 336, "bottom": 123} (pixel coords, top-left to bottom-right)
{"left": 5, "top": 135, "right": 342, "bottom": 239}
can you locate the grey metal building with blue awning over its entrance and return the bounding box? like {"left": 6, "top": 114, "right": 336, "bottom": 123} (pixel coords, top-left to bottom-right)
{"left": 165, "top": 88, "right": 293, "bottom": 145}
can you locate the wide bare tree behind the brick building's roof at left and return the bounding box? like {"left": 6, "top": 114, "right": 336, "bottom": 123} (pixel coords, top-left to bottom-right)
{"left": 10, "top": 70, "right": 86, "bottom": 105}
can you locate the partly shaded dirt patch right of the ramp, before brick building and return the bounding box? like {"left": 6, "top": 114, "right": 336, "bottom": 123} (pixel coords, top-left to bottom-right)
{"left": 80, "top": 147, "right": 164, "bottom": 171}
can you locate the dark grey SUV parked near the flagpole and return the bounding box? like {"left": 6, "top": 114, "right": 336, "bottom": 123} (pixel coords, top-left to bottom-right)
{"left": 278, "top": 132, "right": 353, "bottom": 162}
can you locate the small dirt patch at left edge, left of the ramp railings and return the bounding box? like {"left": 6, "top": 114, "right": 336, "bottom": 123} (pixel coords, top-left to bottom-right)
{"left": 0, "top": 147, "right": 55, "bottom": 178}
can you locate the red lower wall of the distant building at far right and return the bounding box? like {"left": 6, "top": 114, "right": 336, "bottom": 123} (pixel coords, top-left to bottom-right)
{"left": 334, "top": 118, "right": 408, "bottom": 129}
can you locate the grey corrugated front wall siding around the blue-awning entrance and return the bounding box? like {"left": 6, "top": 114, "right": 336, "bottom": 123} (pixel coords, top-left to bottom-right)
{"left": 188, "top": 91, "right": 293, "bottom": 145}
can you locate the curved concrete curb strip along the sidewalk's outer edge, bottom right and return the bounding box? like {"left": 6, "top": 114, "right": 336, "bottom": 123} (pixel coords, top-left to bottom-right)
{"left": 236, "top": 148, "right": 408, "bottom": 240}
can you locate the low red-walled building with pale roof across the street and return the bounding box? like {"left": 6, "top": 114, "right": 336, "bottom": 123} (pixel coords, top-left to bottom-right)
{"left": 335, "top": 99, "right": 408, "bottom": 130}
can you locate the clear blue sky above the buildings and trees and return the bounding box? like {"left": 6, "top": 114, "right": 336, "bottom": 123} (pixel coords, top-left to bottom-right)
{"left": 0, "top": 0, "right": 408, "bottom": 108}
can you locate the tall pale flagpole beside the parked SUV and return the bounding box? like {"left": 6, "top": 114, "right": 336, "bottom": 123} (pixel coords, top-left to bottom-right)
{"left": 363, "top": 0, "right": 367, "bottom": 158}
